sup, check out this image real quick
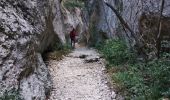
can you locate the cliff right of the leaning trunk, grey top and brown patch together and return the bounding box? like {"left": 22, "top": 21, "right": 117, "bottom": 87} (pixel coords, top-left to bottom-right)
{"left": 122, "top": 0, "right": 170, "bottom": 59}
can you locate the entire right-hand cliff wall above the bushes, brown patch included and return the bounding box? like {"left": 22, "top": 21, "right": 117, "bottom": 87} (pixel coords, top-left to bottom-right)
{"left": 85, "top": 0, "right": 170, "bottom": 55}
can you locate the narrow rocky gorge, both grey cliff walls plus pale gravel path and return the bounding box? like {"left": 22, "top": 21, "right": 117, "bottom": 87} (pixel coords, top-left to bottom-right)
{"left": 0, "top": 0, "right": 170, "bottom": 100}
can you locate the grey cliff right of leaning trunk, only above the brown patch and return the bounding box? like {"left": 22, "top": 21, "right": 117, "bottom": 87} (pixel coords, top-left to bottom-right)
{"left": 121, "top": 0, "right": 170, "bottom": 40}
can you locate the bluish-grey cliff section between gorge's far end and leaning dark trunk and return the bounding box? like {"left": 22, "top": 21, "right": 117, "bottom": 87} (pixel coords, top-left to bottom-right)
{"left": 85, "top": 0, "right": 117, "bottom": 44}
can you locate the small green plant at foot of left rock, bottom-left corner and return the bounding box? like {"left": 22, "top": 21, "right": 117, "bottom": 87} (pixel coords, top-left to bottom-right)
{"left": 0, "top": 89, "right": 21, "bottom": 100}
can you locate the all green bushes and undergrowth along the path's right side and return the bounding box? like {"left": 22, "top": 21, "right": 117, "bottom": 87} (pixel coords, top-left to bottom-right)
{"left": 97, "top": 40, "right": 170, "bottom": 100}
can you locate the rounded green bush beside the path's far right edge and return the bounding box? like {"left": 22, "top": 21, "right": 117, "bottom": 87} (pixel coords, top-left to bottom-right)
{"left": 97, "top": 39, "right": 135, "bottom": 65}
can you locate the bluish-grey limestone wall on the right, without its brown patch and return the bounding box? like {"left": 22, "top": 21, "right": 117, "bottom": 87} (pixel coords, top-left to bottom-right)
{"left": 85, "top": 0, "right": 170, "bottom": 48}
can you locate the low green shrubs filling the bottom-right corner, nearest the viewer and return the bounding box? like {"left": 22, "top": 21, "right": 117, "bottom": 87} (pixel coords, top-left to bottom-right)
{"left": 113, "top": 59, "right": 170, "bottom": 100}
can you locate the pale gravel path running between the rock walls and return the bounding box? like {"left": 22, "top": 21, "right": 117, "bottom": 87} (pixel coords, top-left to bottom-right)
{"left": 48, "top": 48, "right": 116, "bottom": 100}
